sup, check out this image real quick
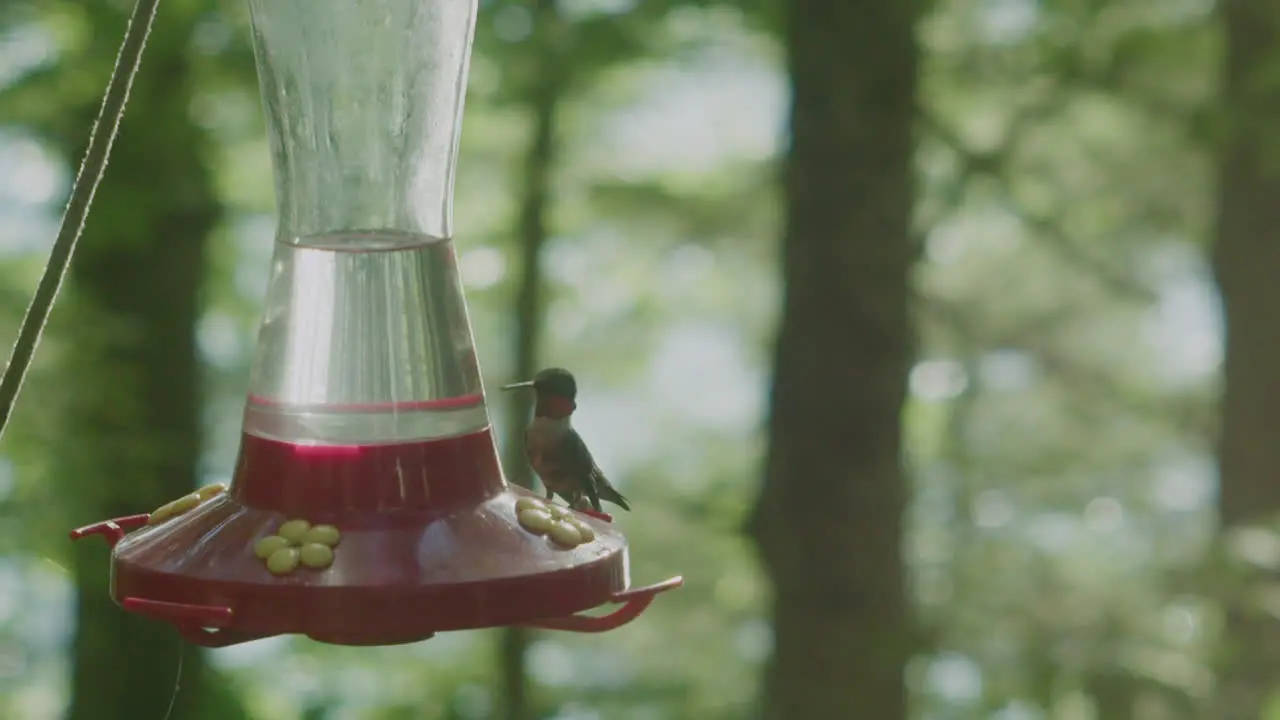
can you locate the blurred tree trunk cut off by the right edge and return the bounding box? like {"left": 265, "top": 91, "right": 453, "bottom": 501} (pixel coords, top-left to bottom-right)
{"left": 1213, "top": 0, "right": 1280, "bottom": 720}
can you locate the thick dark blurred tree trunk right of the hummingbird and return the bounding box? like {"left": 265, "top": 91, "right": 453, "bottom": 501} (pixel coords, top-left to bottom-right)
{"left": 750, "top": 0, "right": 919, "bottom": 720}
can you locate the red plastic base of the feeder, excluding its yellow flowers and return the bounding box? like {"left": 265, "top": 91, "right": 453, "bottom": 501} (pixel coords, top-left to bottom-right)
{"left": 64, "top": 429, "right": 682, "bottom": 647}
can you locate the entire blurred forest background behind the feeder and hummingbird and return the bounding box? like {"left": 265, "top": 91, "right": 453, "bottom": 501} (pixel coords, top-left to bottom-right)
{"left": 0, "top": 0, "right": 1280, "bottom": 720}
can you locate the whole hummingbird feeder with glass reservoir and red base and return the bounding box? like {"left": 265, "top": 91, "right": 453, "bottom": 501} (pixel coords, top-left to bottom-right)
{"left": 72, "top": 0, "right": 682, "bottom": 647}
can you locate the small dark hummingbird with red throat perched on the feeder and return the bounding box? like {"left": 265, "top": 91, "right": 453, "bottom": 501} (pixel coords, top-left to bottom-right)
{"left": 502, "top": 368, "right": 631, "bottom": 511}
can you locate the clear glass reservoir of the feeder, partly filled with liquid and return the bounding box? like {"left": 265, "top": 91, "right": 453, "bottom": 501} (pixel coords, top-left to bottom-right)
{"left": 244, "top": 0, "right": 488, "bottom": 445}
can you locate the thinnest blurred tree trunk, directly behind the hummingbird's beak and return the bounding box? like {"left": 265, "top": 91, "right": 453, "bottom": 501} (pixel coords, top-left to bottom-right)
{"left": 498, "top": 0, "right": 566, "bottom": 720}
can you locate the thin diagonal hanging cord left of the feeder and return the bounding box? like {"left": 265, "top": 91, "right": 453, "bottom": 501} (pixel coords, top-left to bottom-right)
{"left": 0, "top": 0, "right": 160, "bottom": 436}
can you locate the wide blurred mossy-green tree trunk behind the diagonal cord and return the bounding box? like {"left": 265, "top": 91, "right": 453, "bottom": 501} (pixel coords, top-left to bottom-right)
{"left": 52, "top": 3, "right": 244, "bottom": 720}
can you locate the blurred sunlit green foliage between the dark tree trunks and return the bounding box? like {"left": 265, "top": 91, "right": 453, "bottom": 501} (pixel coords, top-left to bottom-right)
{"left": 0, "top": 0, "right": 1259, "bottom": 720}
